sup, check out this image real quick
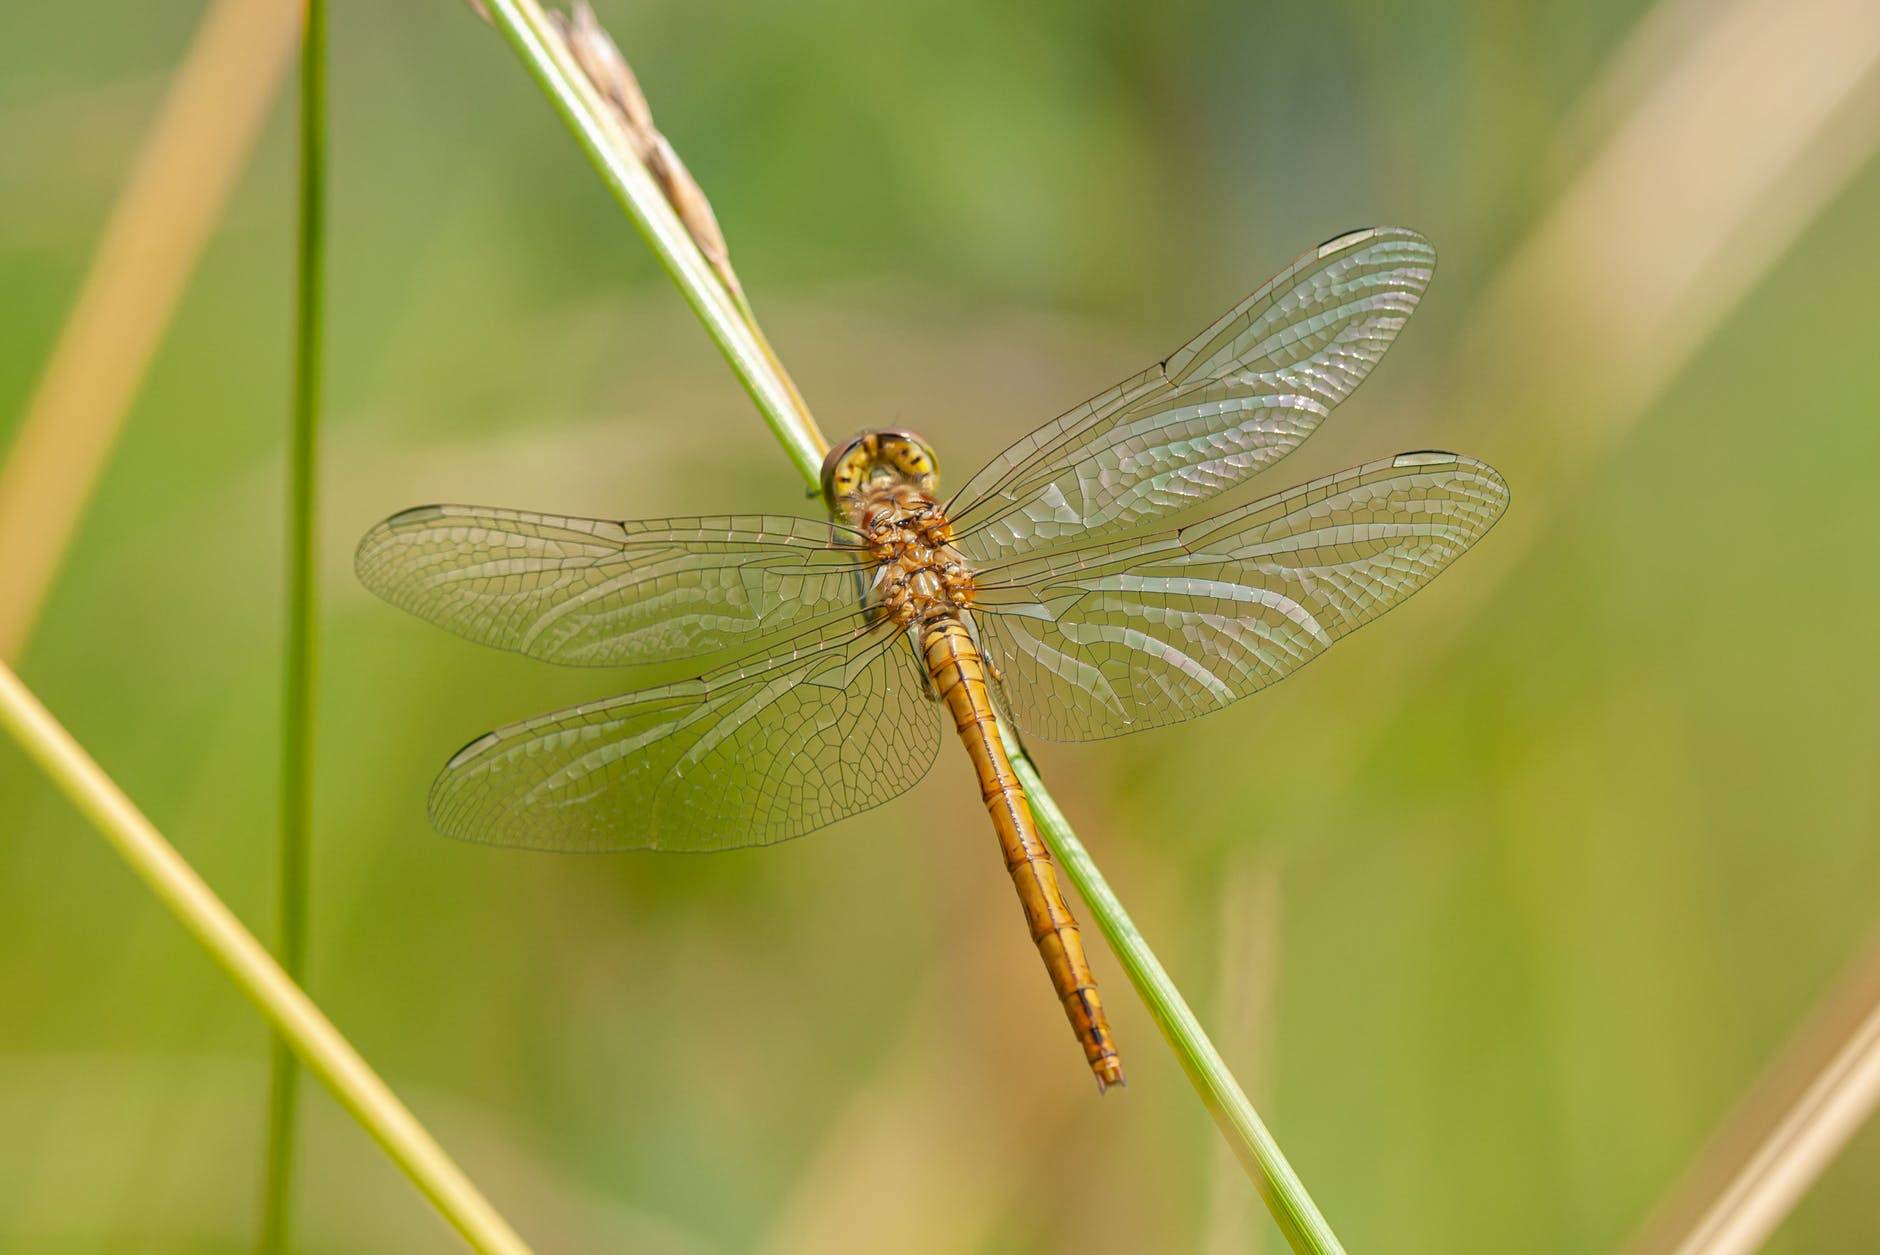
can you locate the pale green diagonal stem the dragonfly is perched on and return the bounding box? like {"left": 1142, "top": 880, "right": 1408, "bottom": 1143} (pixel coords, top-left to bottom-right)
{"left": 477, "top": 0, "right": 1344, "bottom": 1255}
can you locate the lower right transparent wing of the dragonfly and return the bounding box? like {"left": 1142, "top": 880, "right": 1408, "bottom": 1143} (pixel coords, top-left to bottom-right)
{"left": 974, "top": 453, "right": 1508, "bottom": 740}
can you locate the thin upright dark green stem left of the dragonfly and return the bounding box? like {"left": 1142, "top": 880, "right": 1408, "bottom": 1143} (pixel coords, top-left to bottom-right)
{"left": 259, "top": 0, "right": 327, "bottom": 1251}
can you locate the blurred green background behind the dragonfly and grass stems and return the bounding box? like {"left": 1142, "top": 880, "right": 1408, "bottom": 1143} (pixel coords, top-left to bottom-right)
{"left": 0, "top": 0, "right": 1880, "bottom": 1253}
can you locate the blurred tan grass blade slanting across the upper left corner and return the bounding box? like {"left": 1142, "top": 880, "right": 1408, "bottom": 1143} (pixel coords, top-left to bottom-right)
{"left": 0, "top": 0, "right": 301, "bottom": 658}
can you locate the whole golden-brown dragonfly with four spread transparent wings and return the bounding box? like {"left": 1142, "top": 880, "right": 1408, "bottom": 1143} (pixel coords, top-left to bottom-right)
{"left": 355, "top": 227, "right": 1508, "bottom": 1090}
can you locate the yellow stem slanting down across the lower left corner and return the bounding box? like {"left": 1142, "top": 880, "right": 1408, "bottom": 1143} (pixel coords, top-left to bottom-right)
{"left": 0, "top": 663, "right": 528, "bottom": 1255}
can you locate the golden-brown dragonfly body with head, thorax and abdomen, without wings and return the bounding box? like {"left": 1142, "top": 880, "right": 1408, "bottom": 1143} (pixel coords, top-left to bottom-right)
{"left": 823, "top": 432, "right": 1122, "bottom": 1090}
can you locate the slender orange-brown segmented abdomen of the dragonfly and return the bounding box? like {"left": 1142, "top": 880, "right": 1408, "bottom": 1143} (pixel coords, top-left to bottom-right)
{"left": 921, "top": 614, "right": 1122, "bottom": 1090}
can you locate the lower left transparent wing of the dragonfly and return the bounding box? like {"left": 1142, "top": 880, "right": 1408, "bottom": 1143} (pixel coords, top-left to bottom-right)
{"left": 431, "top": 626, "right": 940, "bottom": 851}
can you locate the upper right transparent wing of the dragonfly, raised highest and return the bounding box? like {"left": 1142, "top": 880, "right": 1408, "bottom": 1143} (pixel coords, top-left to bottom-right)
{"left": 948, "top": 227, "right": 1436, "bottom": 566}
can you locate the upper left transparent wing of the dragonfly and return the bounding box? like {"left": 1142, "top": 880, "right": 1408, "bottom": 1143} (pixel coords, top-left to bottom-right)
{"left": 353, "top": 505, "right": 863, "bottom": 667}
